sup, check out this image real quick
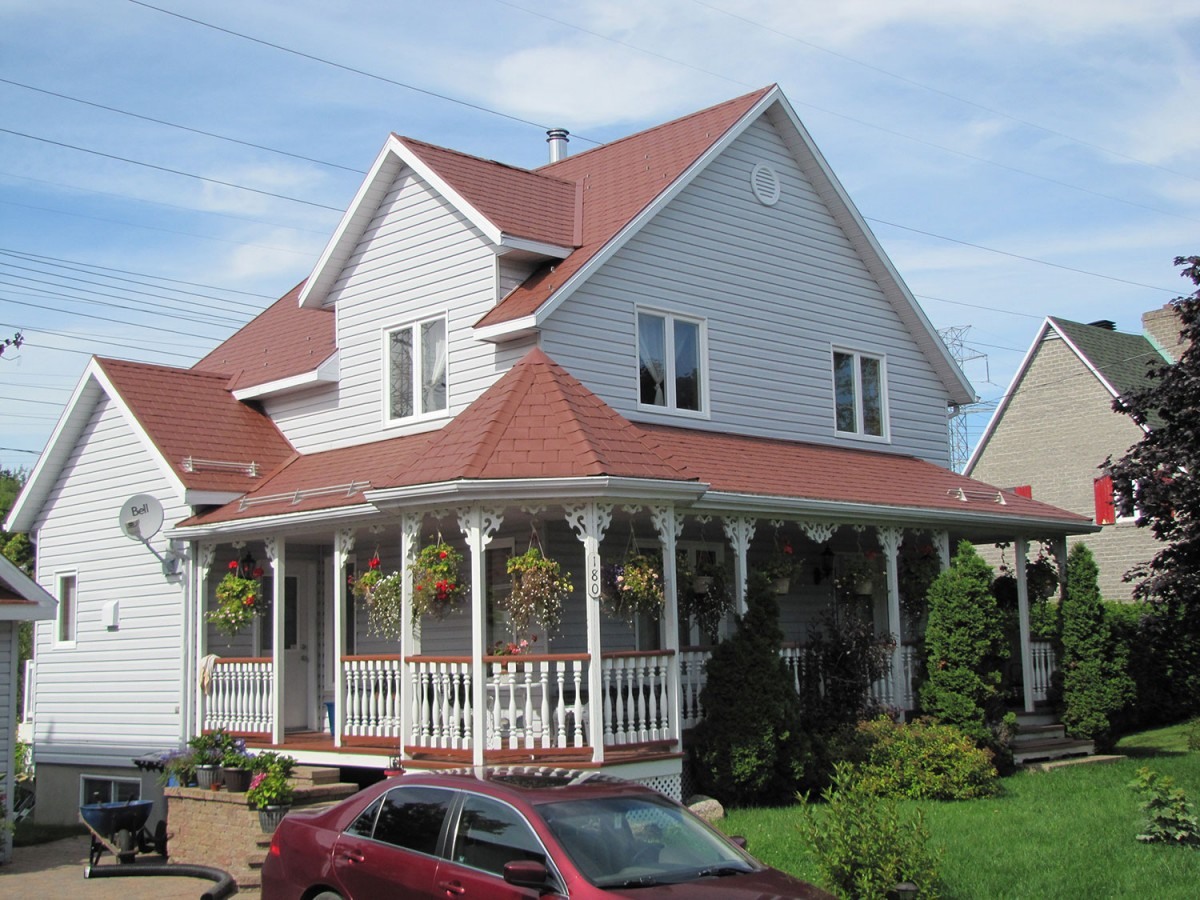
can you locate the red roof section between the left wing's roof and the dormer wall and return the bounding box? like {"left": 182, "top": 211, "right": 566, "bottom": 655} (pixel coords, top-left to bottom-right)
{"left": 192, "top": 282, "right": 337, "bottom": 390}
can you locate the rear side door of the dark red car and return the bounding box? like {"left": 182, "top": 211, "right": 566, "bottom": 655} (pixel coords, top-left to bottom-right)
{"left": 334, "top": 786, "right": 455, "bottom": 900}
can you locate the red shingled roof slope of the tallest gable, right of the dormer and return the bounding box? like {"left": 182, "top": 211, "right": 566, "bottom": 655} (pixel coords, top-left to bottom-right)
{"left": 478, "top": 88, "right": 772, "bottom": 325}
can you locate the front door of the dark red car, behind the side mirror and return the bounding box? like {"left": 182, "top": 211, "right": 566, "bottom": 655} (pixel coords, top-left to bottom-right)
{"left": 434, "top": 793, "right": 560, "bottom": 900}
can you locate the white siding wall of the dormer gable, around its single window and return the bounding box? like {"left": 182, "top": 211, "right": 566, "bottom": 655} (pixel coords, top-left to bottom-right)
{"left": 266, "top": 169, "right": 530, "bottom": 453}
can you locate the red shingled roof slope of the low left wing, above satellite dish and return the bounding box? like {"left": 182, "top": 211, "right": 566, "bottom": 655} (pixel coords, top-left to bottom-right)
{"left": 96, "top": 359, "right": 295, "bottom": 492}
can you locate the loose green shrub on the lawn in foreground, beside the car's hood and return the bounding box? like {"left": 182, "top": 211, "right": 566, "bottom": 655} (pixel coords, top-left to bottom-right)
{"left": 800, "top": 763, "right": 940, "bottom": 900}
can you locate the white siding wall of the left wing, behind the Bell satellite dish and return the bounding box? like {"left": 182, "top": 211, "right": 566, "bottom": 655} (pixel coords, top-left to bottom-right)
{"left": 35, "top": 398, "right": 190, "bottom": 764}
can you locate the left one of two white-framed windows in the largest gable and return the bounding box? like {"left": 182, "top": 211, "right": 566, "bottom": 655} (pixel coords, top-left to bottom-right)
{"left": 637, "top": 310, "right": 707, "bottom": 413}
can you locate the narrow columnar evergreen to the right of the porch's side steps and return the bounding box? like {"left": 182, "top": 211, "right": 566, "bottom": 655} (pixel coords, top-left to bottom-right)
{"left": 1058, "top": 544, "right": 1134, "bottom": 750}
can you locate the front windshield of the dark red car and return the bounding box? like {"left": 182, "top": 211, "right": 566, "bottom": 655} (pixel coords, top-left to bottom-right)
{"left": 538, "top": 796, "right": 758, "bottom": 888}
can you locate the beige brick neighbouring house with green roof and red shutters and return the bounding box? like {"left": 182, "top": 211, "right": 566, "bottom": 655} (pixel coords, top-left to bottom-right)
{"left": 964, "top": 314, "right": 1182, "bottom": 600}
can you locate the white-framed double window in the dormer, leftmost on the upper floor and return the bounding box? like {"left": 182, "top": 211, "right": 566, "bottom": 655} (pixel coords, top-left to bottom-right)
{"left": 385, "top": 318, "right": 446, "bottom": 421}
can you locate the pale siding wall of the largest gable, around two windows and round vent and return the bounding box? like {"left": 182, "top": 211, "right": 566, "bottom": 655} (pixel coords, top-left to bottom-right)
{"left": 542, "top": 119, "right": 948, "bottom": 464}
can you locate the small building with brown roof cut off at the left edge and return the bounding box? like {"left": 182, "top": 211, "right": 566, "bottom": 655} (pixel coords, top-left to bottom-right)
{"left": 0, "top": 556, "right": 55, "bottom": 863}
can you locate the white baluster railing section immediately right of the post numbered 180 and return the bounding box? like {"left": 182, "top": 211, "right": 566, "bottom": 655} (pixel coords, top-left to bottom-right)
{"left": 601, "top": 650, "right": 673, "bottom": 746}
